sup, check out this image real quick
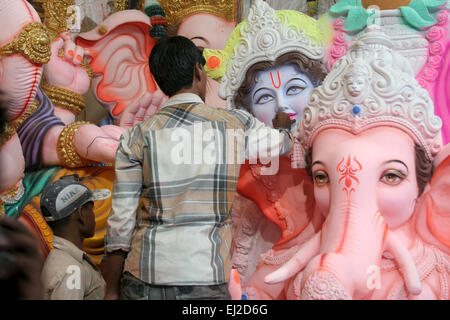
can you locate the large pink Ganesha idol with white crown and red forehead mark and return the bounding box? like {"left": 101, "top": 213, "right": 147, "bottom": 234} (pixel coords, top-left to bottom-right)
{"left": 265, "top": 25, "right": 450, "bottom": 300}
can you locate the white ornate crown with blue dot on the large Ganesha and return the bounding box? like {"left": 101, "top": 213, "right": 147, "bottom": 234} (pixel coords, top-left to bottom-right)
{"left": 296, "top": 25, "right": 442, "bottom": 164}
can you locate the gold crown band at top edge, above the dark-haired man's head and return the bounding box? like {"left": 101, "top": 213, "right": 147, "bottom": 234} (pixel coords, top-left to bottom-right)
{"left": 159, "top": 0, "right": 237, "bottom": 25}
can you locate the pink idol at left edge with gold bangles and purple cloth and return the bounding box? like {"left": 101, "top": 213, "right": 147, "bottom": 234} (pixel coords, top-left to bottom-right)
{"left": 0, "top": 0, "right": 123, "bottom": 195}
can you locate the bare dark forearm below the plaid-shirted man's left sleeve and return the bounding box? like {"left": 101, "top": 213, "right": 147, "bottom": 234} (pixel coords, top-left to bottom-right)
{"left": 100, "top": 250, "right": 127, "bottom": 300}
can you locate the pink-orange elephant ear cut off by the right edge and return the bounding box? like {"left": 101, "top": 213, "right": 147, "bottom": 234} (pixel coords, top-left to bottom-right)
{"left": 415, "top": 144, "right": 450, "bottom": 254}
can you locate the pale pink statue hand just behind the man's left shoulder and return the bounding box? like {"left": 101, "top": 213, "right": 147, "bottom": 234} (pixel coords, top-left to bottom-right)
{"left": 120, "top": 90, "right": 167, "bottom": 129}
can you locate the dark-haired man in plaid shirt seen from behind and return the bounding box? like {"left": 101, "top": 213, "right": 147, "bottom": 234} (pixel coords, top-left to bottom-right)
{"left": 104, "top": 37, "right": 292, "bottom": 299}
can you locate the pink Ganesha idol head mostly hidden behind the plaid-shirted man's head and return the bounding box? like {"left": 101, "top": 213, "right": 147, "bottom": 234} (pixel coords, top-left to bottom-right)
{"left": 76, "top": 0, "right": 237, "bottom": 121}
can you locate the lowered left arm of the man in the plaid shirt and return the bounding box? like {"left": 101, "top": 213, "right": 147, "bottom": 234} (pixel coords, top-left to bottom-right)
{"left": 101, "top": 127, "right": 143, "bottom": 299}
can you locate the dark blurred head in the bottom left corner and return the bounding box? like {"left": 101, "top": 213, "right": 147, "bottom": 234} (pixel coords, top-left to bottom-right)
{"left": 0, "top": 217, "right": 44, "bottom": 300}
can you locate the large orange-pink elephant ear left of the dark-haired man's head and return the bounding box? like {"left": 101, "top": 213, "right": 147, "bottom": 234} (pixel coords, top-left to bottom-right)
{"left": 76, "top": 10, "right": 157, "bottom": 118}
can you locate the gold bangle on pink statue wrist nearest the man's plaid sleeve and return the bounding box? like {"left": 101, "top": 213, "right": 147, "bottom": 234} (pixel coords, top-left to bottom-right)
{"left": 56, "top": 121, "right": 95, "bottom": 168}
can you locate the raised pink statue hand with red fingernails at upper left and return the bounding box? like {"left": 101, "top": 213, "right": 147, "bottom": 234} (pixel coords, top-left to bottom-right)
{"left": 44, "top": 32, "right": 91, "bottom": 95}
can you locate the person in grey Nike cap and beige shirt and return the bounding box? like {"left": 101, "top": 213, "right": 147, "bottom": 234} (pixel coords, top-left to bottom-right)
{"left": 41, "top": 175, "right": 111, "bottom": 300}
